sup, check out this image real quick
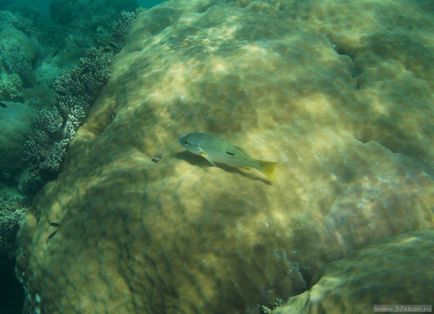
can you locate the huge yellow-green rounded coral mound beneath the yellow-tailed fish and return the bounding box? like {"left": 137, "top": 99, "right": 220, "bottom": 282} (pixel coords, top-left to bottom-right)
{"left": 17, "top": 0, "right": 434, "bottom": 313}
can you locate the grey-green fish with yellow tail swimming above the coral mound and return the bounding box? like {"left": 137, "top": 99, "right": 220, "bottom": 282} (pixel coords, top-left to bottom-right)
{"left": 179, "top": 132, "right": 277, "bottom": 182}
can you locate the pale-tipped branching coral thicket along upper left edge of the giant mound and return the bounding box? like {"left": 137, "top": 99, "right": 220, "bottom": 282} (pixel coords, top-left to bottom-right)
{"left": 20, "top": 49, "right": 113, "bottom": 193}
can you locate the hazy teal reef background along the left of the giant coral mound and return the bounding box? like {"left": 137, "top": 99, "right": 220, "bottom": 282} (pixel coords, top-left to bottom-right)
{"left": 0, "top": 1, "right": 142, "bottom": 313}
